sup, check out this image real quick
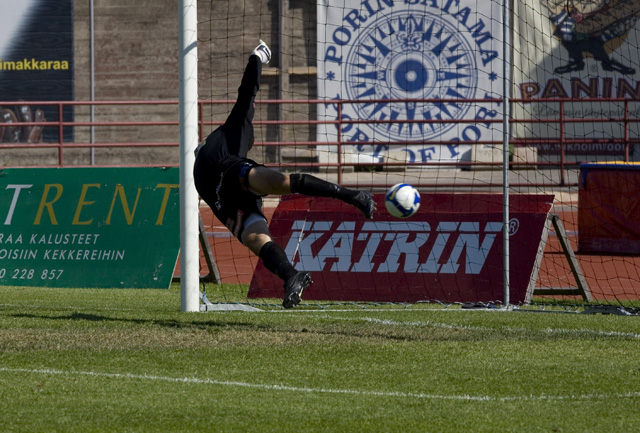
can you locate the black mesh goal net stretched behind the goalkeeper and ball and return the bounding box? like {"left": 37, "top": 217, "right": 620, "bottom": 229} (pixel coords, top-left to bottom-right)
{"left": 190, "top": 0, "right": 640, "bottom": 307}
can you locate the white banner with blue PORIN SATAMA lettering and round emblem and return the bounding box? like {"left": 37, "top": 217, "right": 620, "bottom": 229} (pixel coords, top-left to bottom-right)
{"left": 317, "top": 0, "right": 503, "bottom": 163}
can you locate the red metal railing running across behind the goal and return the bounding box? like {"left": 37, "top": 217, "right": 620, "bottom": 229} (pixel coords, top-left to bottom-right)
{"left": 0, "top": 98, "right": 640, "bottom": 186}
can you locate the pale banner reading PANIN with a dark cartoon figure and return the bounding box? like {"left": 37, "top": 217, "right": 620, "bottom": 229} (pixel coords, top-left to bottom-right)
{"left": 513, "top": 0, "right": 640, "bottom": 162}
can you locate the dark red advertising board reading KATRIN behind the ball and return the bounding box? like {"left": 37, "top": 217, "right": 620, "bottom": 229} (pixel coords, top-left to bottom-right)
{"left": 248, "top": 193, "right": 554, "bottom": 303}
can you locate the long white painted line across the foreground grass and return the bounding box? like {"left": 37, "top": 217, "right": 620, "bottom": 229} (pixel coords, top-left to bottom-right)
{"left": 0, "top": 367, "right": 640, "bottom": 402}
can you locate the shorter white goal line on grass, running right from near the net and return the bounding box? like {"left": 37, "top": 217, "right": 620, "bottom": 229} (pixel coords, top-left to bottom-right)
{"left": 316, "top": 315, "right": 640, "bottom": 339}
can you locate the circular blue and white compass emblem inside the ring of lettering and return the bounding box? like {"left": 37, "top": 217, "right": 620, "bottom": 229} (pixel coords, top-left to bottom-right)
{"left": 345, "top": 11, "right": 478, "bottom": 140}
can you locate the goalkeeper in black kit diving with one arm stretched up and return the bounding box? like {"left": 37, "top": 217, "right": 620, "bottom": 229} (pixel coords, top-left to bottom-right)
{"left": 194, "top": 40, "right": 376, "bottom": 308}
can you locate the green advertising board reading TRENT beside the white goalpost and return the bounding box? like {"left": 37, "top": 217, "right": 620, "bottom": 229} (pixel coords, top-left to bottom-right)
{"left": 0, "top": 168, "right": 180, "bottom": 288}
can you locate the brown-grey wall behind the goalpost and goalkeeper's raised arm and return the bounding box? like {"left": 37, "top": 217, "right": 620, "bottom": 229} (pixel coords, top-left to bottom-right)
{"left": 65, "top": 0, "right": 316, "bottom": 164}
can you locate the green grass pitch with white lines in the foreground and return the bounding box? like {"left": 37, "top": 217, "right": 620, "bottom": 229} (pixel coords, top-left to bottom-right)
{"left": 0, "top": 287, "right": 640, "bottom": 432}
